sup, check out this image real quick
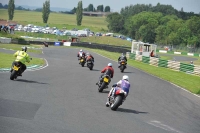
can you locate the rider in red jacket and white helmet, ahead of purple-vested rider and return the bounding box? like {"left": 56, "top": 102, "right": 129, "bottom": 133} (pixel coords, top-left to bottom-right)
{"left": 96, "top": 63, "right": 114, "bottom": 85}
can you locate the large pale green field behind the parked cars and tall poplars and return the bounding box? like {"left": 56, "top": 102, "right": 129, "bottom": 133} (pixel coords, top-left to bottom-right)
{"left": 0, "top": 9, "right": 107, "bottom": 31}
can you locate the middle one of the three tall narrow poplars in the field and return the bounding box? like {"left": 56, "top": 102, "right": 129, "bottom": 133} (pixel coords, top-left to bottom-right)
{"left": 42, "top": 0, "right": 50, "bottom": 23}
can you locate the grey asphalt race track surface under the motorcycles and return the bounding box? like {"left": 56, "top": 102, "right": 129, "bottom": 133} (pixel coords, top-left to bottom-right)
{"left": 0, "top": 47, "right": 200, "bottom": 133}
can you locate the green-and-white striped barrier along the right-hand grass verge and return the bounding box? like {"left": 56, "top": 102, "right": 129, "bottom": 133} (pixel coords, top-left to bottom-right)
{"left": 127, "top": 53, "right": 200, "bottom": 76}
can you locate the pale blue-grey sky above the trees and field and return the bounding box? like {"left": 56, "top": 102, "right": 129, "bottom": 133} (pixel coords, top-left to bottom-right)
{"left": 0, "top": 0, "right": 200, "bottom": 13}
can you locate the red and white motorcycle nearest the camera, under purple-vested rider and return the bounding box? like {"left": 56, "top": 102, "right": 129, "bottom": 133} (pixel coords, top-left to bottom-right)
{"left": 109, "top": 88, "right": 127, "bottom": 111}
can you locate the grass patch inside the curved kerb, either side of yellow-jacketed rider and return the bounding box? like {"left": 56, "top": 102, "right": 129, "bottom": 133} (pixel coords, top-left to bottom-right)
{"left": 0, "top": 53, "right": 45, "bottom": 68}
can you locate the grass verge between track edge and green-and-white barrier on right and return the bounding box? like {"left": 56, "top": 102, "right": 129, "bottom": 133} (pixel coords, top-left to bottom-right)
{"left": 69, "top": 48, "right": 200, "bottom": 94}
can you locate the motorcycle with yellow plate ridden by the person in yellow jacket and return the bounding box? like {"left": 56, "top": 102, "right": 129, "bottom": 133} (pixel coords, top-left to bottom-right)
{"left": 10, "top": 62, "right": 21, "bottom": 80}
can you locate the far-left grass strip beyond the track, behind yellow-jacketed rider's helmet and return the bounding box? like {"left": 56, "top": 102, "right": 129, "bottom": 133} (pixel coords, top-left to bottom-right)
{"left": 0, "top": 44, "right": 42, "bottom": 54}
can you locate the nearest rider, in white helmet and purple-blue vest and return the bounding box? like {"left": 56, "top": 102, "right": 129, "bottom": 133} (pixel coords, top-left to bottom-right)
{"left": 106, "top": 75, "right": 130, "bottom": 107}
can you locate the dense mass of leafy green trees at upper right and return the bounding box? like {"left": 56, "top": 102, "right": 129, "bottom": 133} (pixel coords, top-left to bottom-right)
{"left": 106, "top": 3, "right": 200, "bottom": 47}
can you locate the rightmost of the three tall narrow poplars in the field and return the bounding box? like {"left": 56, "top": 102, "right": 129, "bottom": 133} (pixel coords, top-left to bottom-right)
{"left": 76, "top": 1, "right": 83, "bottom": 25}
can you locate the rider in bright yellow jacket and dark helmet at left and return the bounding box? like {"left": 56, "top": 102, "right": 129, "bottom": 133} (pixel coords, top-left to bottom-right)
{"left": 11, "top": 47, "right": 30, "bottom": 76}
